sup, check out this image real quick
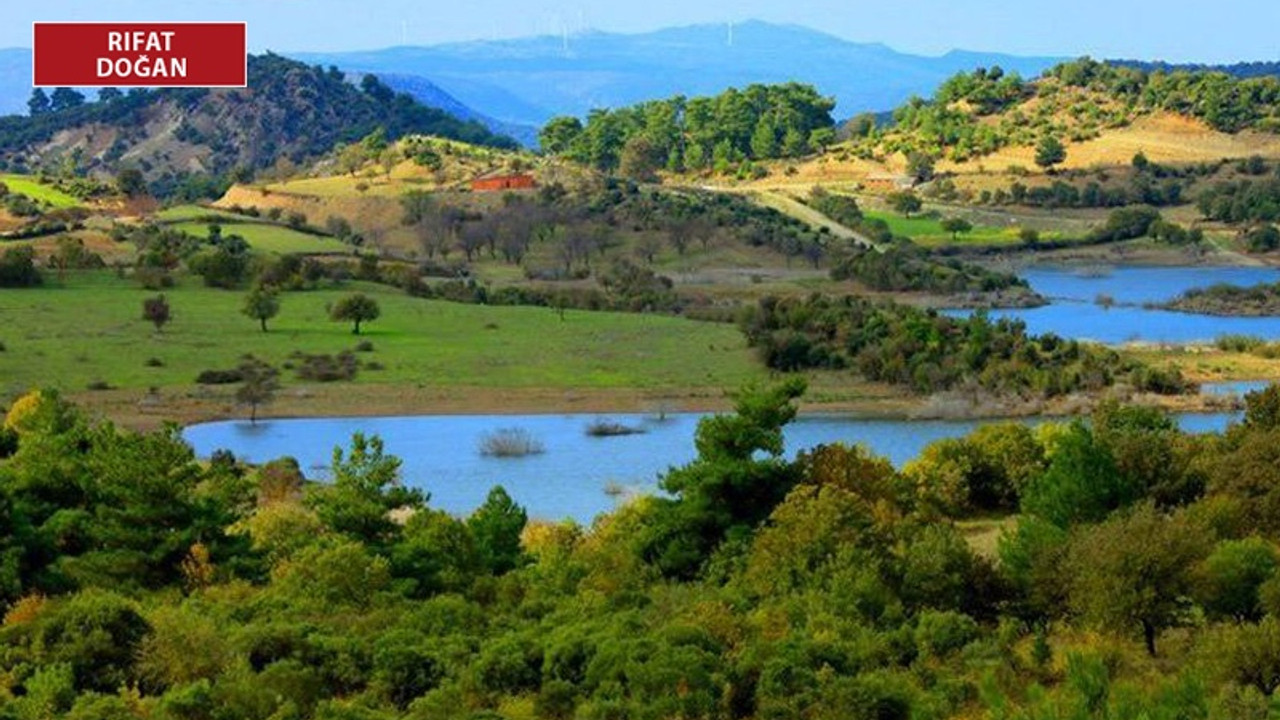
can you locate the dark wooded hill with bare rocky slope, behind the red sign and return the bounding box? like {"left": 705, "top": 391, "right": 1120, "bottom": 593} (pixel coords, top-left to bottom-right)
{"left": 0, "top": 54, "right": 516, "bottom": 192}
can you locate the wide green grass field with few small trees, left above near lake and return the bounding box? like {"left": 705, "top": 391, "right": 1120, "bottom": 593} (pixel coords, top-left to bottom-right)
{"left": 0, "top": 272, "right": 764, "bottom": 397}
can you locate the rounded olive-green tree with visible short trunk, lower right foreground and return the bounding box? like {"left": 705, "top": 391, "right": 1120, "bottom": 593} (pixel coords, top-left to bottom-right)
{"left": 1066, "top": 503, "right": 1208, "bottom": 656}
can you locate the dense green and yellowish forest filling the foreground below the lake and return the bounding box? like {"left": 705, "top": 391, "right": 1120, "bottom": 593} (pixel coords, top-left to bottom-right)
{"left": 0, "top": 380, "right": 1280, "bottom": 720}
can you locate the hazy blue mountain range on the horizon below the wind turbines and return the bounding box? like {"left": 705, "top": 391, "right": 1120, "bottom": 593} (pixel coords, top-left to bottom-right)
{"left": 291, "top": 22, "right": 1061, "bottom": 126}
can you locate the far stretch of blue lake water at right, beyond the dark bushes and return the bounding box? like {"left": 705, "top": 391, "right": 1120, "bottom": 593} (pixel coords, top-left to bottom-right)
{"left": 955, "top": 266, "right": 1280, "bottom": 345}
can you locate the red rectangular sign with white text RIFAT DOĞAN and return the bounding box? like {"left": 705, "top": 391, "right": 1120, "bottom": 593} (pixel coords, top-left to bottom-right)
{"left": 32, "top": 23, "right": 248, "bottom": 87}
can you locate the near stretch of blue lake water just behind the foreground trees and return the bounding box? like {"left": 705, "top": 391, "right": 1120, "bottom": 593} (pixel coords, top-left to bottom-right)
{"left": 183, "top": 404, "right": 1233, "bottom": 523}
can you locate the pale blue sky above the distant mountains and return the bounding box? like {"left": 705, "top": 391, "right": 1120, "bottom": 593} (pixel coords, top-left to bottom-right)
{"left": 0, "top": 0, "right": 1280, "bottom": 63}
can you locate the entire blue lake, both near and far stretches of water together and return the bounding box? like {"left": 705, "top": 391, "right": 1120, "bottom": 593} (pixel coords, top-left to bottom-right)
{"left": 183, "top": 268, "right": 1280, "bottom": 523}
